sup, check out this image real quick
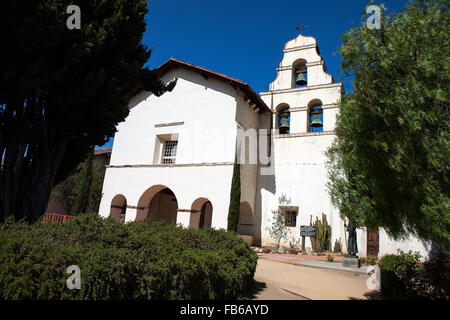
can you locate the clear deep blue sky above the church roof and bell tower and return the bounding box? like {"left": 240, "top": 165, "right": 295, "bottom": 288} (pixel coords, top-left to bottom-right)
{"left": 99, "top": 0, "right": 408, "bottom": 147}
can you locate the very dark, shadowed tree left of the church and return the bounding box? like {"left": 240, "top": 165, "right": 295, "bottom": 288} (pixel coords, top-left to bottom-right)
{"left": 0, "top": 0, "right": 175, "bottom": 220}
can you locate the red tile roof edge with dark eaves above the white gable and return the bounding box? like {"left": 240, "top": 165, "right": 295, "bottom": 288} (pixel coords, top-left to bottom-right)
{"left": 158, "top": 58, "right": 271, "bottom": 112}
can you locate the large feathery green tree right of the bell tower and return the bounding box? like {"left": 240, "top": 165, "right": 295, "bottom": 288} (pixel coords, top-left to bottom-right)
{"left": 328, "top": 0, "right": 450, "bottom": 248}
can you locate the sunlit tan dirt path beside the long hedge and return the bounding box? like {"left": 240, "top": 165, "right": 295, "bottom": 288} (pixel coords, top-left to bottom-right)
{"left": 255, "top": 258, "right": 380, "bottom": 300}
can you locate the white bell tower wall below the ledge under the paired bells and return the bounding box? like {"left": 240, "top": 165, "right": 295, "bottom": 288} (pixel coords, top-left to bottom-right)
{"left": 262, "top": 134, "right": 341, "bottom": 245}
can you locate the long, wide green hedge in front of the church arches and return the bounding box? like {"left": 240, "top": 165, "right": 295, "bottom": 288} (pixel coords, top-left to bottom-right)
{"left": 0, "top": 214, "right": 257, "bottom": 299}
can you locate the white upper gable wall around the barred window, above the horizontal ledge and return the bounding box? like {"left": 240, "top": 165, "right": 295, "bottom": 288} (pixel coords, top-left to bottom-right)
{"left": 110, "top": 69, "right": 236, "bottom": 165}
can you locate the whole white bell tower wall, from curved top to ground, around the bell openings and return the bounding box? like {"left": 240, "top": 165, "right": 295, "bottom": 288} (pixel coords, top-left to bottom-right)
{"left": 260, "top": 35, "right": 342, "bottom": 247}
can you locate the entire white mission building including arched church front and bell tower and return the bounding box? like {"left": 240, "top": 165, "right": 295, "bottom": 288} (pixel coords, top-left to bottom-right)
{"left": 100, "top": 35, "right": 430, "bottom": 257}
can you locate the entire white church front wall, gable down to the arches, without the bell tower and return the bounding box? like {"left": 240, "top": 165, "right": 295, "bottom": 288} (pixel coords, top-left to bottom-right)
{"left": 100, "top": 68, "right": 266, "bottom": 228}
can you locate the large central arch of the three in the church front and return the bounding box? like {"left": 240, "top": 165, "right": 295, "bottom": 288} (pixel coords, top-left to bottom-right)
{"left": 136, "top": 185, "right": 178, "bottom": 223}
